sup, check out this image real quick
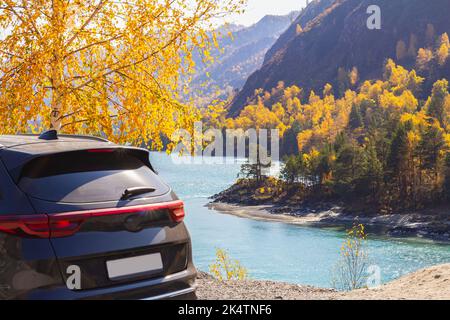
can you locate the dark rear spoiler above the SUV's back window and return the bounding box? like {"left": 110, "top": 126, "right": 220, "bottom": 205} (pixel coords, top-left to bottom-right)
{"left": 0, "top": 145, "right": 157, "bottom": 183}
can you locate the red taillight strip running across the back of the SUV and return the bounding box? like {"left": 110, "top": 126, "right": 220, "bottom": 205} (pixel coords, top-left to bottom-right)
{"left": 0, "top": 200, "right": 185, "bottom": 238}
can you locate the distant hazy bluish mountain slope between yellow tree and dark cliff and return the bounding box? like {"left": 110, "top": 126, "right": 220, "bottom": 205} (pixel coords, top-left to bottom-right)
{"left": 190, "top": 11, "right": 299, "bottom": 102}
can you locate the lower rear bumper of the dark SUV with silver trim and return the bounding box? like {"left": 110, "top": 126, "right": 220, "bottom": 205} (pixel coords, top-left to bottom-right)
{"left": 19, "top": 266, "right": 197, "bottom": 300}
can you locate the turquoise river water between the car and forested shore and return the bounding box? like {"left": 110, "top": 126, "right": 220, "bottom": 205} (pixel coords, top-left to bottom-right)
{"left": 150, "top": 153, "right": 450, "bottom": 287}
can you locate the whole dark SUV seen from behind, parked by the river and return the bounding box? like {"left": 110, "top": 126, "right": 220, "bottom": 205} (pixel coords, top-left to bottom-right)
{"left": 0, "top": 134, "right": 196, "bottom": 300}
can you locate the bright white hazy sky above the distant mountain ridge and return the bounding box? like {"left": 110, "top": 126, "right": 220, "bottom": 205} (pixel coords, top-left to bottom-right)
{"left": 227, "top": 0, "right": 306, "bottom": 26}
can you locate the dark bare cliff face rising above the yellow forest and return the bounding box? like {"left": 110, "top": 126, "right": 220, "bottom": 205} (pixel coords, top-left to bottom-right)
{"left": 229, "top": 0, "right": 450, "bottom": 116}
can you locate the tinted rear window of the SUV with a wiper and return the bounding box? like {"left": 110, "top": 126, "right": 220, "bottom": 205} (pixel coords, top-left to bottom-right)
{"left": 18, "top": 149, "right": 169, "bottom": 203}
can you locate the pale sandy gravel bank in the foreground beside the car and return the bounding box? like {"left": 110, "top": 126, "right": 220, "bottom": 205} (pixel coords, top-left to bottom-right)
{"left": 197, "top": 264, "right": 450, "bottom": 300}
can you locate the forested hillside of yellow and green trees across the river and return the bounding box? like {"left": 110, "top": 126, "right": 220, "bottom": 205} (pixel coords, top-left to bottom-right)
{"left": 205, "top": 55, "right": 450, "bottom": 213}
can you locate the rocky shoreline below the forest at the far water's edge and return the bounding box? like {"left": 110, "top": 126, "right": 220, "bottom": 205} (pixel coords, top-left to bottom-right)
{"left": 208, "top": 199, "right": 450, "bottom": 243}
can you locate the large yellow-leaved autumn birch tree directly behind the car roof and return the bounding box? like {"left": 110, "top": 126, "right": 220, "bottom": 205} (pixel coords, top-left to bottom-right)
{"left": 0, "top": 0, "right": 245, "bottom": 148}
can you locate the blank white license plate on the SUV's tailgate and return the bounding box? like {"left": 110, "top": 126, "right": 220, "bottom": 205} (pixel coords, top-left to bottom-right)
{"left": 106, "top": 253, "right": 163, "bottom": 280}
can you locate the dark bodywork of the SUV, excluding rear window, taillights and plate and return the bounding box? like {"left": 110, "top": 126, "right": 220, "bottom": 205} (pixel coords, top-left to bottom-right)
{"left": 0, "top": 135, "right": 196, "bottom": 299}
